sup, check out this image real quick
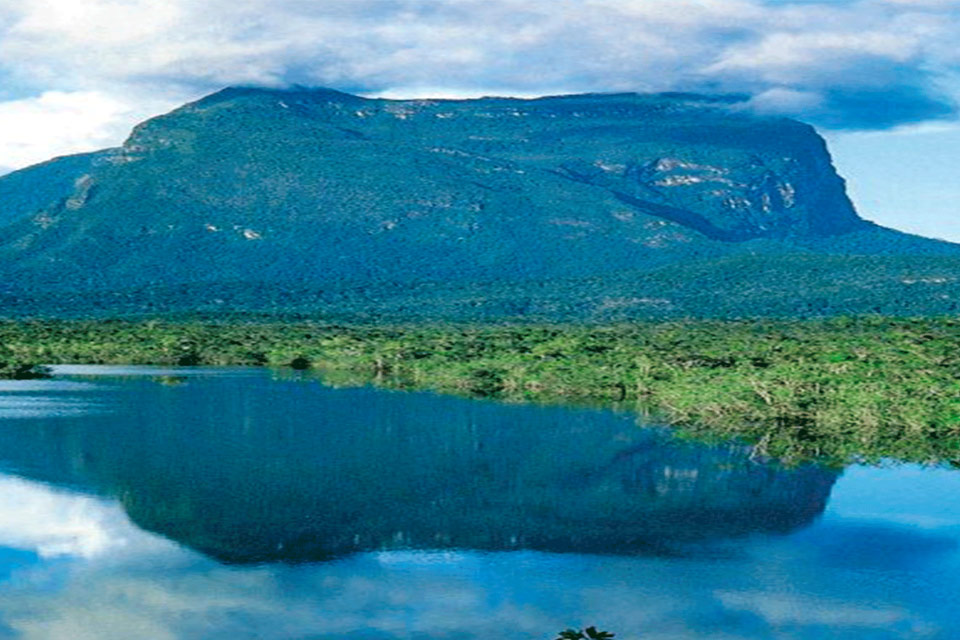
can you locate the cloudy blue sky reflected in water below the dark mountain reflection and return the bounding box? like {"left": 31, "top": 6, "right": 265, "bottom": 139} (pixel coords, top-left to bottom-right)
{"left": 0, "top": 468, "right": 960, "bottom": 640}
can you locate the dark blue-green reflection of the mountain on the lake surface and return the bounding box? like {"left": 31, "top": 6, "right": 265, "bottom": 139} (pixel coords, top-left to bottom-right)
{"left": 0, "top": 371, "right": 837, "bottom": 563}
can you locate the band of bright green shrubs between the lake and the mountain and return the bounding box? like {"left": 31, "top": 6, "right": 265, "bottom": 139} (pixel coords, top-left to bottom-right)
{"left": 0, "top": 317, "right": 960, "bottom": 465}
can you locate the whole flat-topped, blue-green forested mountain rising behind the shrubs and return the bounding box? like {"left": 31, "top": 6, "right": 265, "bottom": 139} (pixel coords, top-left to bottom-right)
{"left": 0, "top": 88, "right": 960, "bottom": 320}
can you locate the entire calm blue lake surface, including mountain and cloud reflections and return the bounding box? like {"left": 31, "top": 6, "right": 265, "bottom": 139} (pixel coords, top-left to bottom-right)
{"left": 0, "top": 367, "right": 960, "bottom": 640}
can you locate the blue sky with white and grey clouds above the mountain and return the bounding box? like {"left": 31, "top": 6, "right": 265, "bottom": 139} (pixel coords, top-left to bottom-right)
{"left": 0, "top": 0, "right": 960, "bottom": 241}
